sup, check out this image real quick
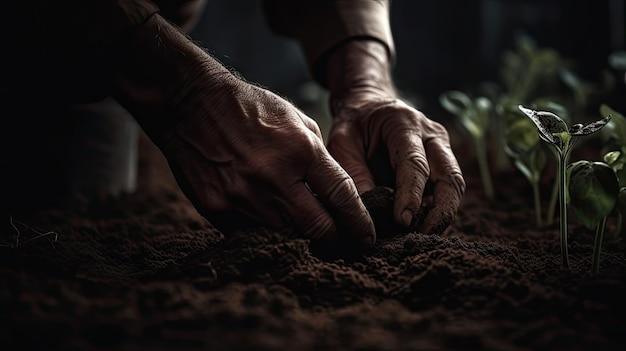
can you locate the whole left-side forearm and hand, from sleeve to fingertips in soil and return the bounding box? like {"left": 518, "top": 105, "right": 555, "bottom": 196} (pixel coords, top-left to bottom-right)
{"left": 115, "top": 15, "right": 375, "bottom": 251}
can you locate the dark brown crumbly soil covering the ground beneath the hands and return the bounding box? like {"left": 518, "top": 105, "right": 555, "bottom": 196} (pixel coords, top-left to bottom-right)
{"left": 0, "top": 131, "right": 626, "bottom": 350}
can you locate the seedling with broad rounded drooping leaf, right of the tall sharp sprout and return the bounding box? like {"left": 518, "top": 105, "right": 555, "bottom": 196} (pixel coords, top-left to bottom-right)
{"left": 567, "top": 160, "right": 619, "bottom": 273}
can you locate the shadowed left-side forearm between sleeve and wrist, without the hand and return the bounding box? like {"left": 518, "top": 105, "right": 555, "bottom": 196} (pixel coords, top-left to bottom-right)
{"left": 113, "top": 15, "right": 238, "bottom": 145}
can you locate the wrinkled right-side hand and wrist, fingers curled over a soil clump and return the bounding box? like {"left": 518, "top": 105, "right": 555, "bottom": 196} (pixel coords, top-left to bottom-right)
{"left": 328, "top": 41, "right": 465, "bottom": 233}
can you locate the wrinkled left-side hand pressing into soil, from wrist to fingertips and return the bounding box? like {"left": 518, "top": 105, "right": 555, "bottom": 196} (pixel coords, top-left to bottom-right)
{"left": 161, "top": 77, "right": 375, "bottom": 246}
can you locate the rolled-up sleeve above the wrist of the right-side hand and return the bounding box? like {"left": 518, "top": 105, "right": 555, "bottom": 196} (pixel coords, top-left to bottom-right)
{"left": 262, "top": 0, "right": 395, "bottom": 81}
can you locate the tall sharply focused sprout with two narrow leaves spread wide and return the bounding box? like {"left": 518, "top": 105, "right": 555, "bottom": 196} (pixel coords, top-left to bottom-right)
{"left": 518, "top": 105, "right": 611, "bottom": 268}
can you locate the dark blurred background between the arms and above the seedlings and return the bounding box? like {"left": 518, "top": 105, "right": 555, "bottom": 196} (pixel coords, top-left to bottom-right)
{"left": 191, "top": 0, "right": 626, "bottom": 140}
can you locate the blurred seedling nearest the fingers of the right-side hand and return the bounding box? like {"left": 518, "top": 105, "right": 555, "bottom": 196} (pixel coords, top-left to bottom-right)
{"left": 439, "top": 90, "right": 494, "bottom": 199}
